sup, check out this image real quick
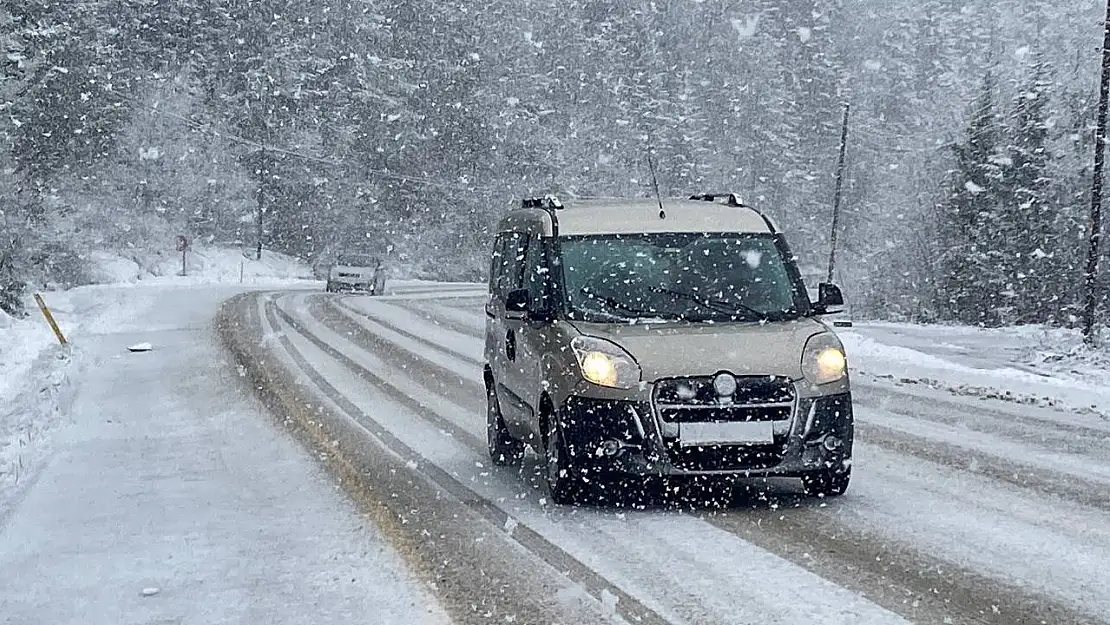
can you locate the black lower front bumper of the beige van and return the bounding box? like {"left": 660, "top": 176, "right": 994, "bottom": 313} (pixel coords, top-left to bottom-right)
{"left": 559, "top": 393, "right": 855, "bottom": 477}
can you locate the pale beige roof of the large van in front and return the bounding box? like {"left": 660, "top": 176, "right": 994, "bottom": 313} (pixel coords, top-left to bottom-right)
{"left": 500, "top": 199, "right": 777, "bottom": 236}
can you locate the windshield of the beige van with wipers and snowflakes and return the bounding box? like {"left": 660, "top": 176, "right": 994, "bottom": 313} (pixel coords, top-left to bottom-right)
{"left": 559, "top": 233, "right": 808, "bottom": 323}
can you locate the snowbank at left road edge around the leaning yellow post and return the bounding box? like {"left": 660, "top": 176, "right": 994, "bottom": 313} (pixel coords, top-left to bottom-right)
{"left": 0, "top": 249, "right": 320, "bottom": 516}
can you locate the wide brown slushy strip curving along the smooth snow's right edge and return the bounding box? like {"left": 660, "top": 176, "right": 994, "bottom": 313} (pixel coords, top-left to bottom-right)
{"left": 223, "top": 293, "right": 643, "bottom": 625}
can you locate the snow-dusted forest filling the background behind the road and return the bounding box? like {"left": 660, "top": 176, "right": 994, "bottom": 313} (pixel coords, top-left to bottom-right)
{"left": 0, "top": 0, "right": 1106, "bottom": 326}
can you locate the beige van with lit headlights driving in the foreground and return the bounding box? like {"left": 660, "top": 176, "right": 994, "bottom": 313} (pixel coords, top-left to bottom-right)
{"left": 485, "top": 194, "right": 854, "bottom": 503}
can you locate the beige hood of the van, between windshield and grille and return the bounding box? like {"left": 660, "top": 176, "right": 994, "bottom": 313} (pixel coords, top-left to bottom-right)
{"left": 574, "top": 319, "right": 828, "bottom": 382}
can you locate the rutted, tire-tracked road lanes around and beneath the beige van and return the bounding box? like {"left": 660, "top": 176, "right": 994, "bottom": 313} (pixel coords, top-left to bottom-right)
{"left": 216, "top": 286, "right": 1110, "bottom": 625}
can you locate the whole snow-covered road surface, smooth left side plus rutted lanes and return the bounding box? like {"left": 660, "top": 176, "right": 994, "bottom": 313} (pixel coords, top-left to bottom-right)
{"left": 0, "top": 284, "right": 1110, "bottom": 625}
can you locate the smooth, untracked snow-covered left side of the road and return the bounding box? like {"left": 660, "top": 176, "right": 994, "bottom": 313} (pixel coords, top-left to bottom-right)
{"left": 0, "top": 286, "right": 447, "bottom": 625}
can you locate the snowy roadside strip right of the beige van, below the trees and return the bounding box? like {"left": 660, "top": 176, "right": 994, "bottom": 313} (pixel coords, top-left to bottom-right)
{"left": 837, "top": 322, "right": 1110, "bottom": 419}
